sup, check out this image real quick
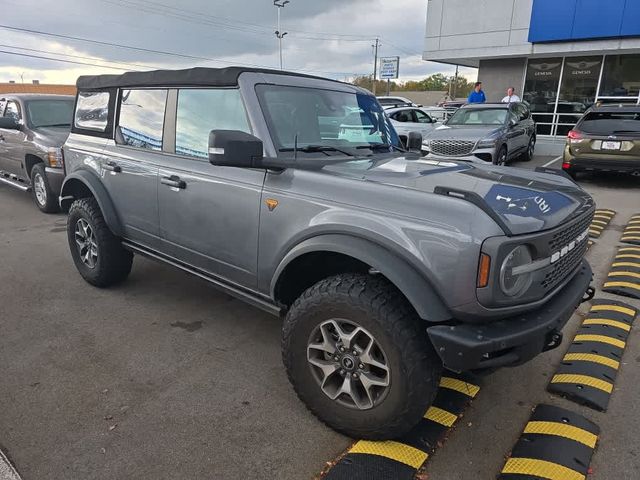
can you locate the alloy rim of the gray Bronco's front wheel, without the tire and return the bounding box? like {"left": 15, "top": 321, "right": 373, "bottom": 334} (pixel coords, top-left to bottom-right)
{"left": 307, "top": 318, "right": 391, "bottom": 410}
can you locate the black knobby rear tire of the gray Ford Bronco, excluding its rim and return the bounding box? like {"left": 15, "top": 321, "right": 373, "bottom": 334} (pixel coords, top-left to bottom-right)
{"left": 67, "top": 197, "right": 133, "bottom": 288}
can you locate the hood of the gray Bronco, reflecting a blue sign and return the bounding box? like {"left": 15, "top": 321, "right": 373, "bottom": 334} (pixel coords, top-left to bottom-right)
{"left": 323, "top": 155, "right": 594, "bottom": 235}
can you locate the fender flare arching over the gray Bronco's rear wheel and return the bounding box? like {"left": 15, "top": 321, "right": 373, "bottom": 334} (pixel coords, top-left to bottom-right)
{"left": 60, "top": 170, "right": 123, "bottom": 237}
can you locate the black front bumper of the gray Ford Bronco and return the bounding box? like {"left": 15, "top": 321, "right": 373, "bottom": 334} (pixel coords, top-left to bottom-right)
{"left": 427, "top": 260, "right": 593, "bottom": 371}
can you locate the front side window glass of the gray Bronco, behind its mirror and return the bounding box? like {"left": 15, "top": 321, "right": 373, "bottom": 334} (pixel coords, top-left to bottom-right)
{"left": 176, "top": 89, "right": 251, "bottom": 159}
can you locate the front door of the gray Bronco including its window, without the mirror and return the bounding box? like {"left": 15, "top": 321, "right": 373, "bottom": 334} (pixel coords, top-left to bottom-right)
{"left": 158, "top": 88, "right": 266, "bottom": 288}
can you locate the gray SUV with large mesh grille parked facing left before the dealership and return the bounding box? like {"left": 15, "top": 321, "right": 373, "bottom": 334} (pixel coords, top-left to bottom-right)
{"left": 422, "top": 103, "right": 536, "bottom": 165}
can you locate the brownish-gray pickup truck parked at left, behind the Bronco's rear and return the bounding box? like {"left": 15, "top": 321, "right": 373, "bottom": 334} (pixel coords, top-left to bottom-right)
{"left": 0, "top": 94, "right": 74, "bottom": 213}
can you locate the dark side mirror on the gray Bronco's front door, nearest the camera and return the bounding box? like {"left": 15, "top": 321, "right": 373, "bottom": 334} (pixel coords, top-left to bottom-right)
{"left": 209, "top": 130, "right": 263, "bottom": 168}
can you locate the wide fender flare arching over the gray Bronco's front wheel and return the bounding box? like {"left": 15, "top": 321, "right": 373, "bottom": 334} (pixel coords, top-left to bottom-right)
{"left": 271, "top": 234, "right": 452, "bottom": 322}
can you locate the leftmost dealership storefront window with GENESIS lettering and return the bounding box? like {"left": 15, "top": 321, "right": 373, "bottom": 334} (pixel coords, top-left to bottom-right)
{"left": 523, "top": 58, "right": 562, "bottom": 135}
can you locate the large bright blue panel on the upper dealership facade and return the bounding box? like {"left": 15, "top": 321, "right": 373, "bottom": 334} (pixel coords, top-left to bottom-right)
{"left": 529, "top": 0, "right": 640, "bottom": 43}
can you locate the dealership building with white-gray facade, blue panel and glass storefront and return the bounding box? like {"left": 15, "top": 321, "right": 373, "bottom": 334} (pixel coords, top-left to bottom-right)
{"left": 423, "top": 0, "right": 640, "bottom": 148}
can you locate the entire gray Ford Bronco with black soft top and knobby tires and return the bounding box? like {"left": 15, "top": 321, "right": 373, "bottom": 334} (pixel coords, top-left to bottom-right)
{"left": 60, "top": 67, "right": 595, "bottom": 439}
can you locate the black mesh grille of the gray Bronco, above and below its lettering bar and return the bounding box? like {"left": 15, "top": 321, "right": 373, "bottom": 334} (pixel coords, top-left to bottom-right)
{"left": 542, "top": 212, "right": 593, "bottom": 290}
